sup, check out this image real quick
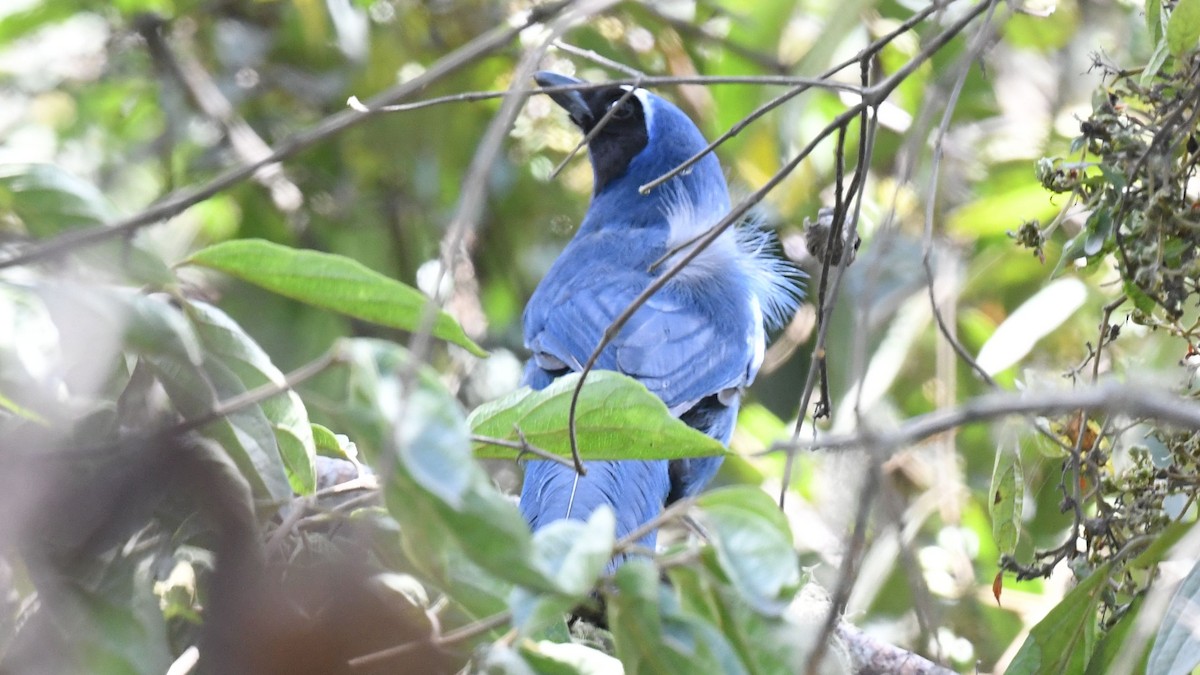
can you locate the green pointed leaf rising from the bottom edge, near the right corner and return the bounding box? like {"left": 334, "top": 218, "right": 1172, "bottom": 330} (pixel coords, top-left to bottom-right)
{"left": 1008, "top": 561, "right": 1112, "bottom": 675}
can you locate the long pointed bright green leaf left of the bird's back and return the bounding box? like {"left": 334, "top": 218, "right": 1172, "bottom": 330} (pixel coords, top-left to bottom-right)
{"left": 187, "top": 239, "right": 487, "bottom": 357}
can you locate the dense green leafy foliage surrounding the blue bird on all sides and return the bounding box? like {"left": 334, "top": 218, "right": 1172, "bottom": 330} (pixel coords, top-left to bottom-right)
{"left": 0, "top": 0, "right": 1200, "bottom": 674}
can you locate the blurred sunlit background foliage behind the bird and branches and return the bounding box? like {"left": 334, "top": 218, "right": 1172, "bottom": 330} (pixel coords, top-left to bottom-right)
{"left": 0, "top": 0, "right": 1195, "bottom": 671}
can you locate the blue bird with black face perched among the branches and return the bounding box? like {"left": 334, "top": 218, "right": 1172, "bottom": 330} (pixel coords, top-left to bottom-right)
{"left": 521, "top": 72, "right": 800, "bottom": 549}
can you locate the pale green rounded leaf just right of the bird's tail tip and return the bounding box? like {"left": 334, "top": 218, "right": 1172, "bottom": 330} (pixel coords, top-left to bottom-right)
{"left": 696, "top": 485, "right": 802, "bottom": 615}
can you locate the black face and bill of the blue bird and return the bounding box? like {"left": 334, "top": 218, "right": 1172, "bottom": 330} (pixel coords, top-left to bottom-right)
{"left": 534, "top": 71, "right": 649, "bottom": 193}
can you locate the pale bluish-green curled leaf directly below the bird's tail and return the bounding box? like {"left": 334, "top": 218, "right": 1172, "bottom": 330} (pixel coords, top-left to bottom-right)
{"left": 510, "top": 508, "right": 616, "bottom": 635}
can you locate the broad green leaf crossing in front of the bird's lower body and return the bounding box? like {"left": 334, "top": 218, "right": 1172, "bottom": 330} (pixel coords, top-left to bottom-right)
{"left": 467, "top": 371, "right": 726, "bottom": 460}
